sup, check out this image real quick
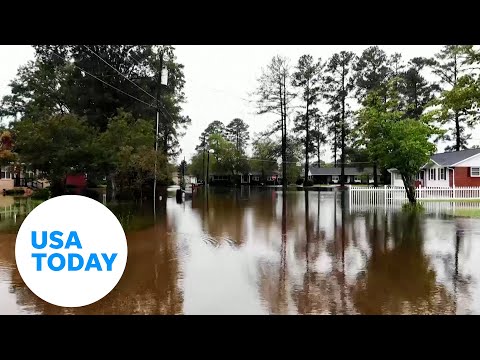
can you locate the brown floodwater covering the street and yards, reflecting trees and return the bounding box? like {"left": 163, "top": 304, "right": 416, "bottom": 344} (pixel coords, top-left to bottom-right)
{"left": 0, "top": 188, "right": 480, "bottom": 314}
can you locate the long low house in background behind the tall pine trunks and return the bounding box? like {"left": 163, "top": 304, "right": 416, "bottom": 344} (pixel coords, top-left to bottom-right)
{"left": 302, "top": 166, "right": 380, "bottom": 184}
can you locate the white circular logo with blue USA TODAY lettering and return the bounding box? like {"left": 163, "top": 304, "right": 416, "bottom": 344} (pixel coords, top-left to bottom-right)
{"left": 15, "top": 195, "right": 128, "bottom": 307}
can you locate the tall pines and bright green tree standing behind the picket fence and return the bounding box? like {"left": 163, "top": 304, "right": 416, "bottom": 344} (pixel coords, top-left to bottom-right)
{"left": 251, "top": 45, "right": 480, "bottom": 202}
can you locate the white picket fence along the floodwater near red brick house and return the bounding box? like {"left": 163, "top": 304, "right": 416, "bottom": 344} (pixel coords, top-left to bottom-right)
{"left": 348, "top": 186, "right": 480, "bottom": 207}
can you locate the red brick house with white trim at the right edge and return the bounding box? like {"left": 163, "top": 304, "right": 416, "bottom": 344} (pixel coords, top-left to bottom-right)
{"left": 388, "top": 149, "right": 480, "bottom": 187}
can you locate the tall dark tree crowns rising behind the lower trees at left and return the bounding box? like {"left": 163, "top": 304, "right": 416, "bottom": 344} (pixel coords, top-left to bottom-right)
{"left": 0, "top": 45, "right": 190, "bottom": 155}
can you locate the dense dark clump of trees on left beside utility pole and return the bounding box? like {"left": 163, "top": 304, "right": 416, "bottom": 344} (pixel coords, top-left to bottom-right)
{"left": 0, "top": 45, "right": 190, "bottom": 196}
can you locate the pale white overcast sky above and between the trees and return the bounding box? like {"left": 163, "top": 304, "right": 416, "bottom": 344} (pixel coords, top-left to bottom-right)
{"left": 0, "top": 45, "right": 480, "bottom": 159}
